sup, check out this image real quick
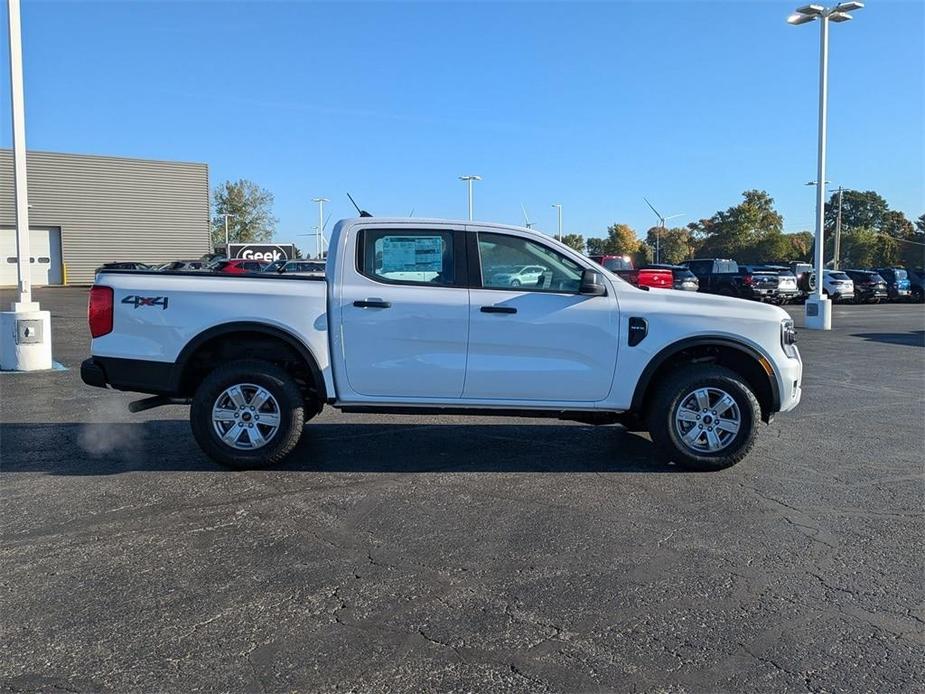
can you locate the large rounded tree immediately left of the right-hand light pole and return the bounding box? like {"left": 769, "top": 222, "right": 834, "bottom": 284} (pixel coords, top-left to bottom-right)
{"left": 688, "top": 190, "right": 786, "bottom": 263}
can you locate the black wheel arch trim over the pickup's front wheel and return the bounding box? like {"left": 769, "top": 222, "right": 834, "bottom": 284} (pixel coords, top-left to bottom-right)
{"left": 631, "top": 336, "right": 780, "bottom": 422}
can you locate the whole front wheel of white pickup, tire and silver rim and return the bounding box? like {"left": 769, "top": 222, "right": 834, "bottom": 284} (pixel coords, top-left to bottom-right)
{"left": 648, "top": 366, "right": 761, "bottom": 470}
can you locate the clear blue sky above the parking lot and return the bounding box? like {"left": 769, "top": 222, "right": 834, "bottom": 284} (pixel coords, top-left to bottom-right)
{"left": 0, "top": 0, "right": 925, "bottom": 246}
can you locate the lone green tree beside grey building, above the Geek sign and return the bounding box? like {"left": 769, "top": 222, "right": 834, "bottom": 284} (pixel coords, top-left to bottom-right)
{"left": 212, "top": 178, "right": 278, "bottom": 246}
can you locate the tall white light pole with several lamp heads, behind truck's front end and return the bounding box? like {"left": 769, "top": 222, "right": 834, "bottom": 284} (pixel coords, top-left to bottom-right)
{"left": 787, "top": 2, "right": 864, "bottom": 330}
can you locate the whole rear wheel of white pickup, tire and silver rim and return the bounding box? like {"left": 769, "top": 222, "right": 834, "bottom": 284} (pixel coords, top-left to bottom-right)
{"left": 190, "top": 359, "right": 305, "bottom": 469}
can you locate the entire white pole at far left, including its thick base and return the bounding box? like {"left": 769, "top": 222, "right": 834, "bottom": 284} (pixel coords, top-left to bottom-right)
{"left": 0, "top": 0, "right": 52, "bottom": 371}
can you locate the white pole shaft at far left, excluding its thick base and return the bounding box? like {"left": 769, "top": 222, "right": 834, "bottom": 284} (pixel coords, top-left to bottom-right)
{"left": 7, "top": 0, "right": 39, "bottom": 311}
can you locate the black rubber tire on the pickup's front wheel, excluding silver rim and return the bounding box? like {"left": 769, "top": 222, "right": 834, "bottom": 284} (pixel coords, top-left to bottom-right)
{"left": 647, "top": 365, "right": 761, "bottom": 471}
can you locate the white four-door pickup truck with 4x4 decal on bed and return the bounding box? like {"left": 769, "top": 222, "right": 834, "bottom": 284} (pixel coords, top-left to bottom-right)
{"left": 81, "top": 217, "right": 803, "bottom": 469}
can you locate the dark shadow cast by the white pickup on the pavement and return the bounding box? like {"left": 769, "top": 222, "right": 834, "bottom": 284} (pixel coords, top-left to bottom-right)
{"left": 0, "top": 420, "right": 678, "bottom": 475}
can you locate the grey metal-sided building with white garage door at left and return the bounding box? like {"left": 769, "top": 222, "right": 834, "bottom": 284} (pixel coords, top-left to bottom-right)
{"left": 0, "top": 149, "right": 210, "bottom": 286}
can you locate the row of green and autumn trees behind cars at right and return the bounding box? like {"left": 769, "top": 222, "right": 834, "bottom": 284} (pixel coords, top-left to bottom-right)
{"left": 562, "top": 190, "right": 925, "bottom": 268}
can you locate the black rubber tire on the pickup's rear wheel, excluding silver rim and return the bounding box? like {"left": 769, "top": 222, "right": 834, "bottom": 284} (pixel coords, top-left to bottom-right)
{"left": 190, "top": 359, "right": 305, "bottom": 470}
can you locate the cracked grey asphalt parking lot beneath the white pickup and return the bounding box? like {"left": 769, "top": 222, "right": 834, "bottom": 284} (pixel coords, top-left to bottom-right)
{"left": 0, "top": 288, "right": 925, "bottom": 692}
